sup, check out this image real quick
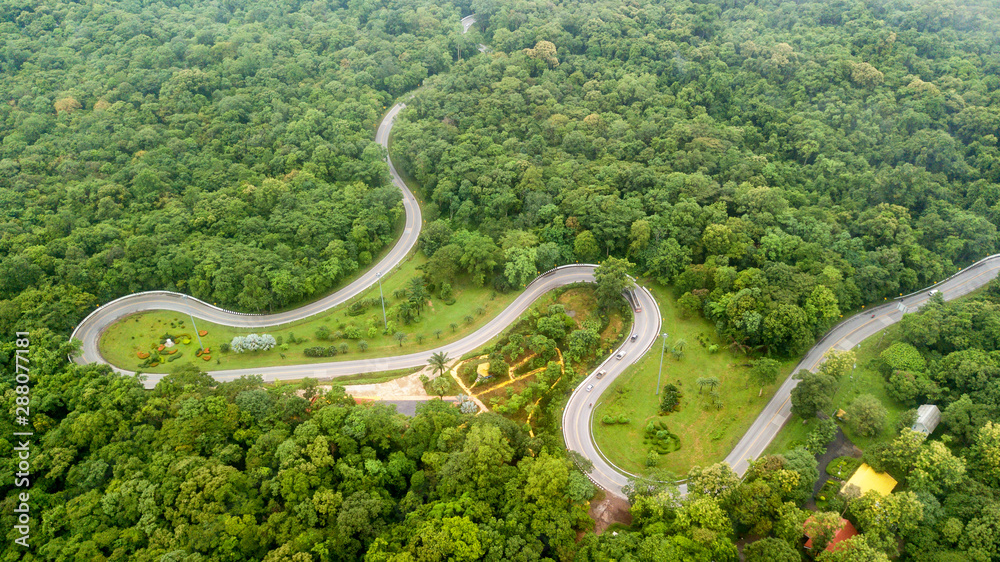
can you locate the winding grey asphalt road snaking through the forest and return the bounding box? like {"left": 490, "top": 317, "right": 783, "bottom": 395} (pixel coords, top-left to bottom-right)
{"left": 66, "top": 12, "right": 1000, "bottom": 496}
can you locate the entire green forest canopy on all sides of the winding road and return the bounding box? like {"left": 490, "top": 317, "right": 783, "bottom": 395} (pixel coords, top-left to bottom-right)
{"left": 0, "top": 0, "right": 1000, "bottom": 562}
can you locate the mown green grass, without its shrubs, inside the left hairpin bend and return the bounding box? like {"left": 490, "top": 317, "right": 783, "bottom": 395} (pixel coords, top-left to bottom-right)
{"left": 100, "top": 254, "right": 518, "bottom": 373}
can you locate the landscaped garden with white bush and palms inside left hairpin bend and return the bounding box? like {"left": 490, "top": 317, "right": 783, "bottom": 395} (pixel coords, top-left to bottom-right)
{"left": 100, "top": 253, "right": 518, "bottom": 373}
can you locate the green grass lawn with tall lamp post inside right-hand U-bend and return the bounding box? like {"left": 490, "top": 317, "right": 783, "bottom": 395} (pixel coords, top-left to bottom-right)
{"left": 594, "top": 280, "right": 795, "bottom": 477}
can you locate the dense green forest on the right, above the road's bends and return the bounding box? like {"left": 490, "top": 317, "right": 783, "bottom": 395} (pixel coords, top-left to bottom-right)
{"left": 394, "top": 1, "right": 1000, "bottom": 354}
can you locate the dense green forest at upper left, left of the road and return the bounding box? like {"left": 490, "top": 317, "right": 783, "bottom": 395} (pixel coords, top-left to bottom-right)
{"left": 0, "top": 0, "right": 484, "bottom": 332}
